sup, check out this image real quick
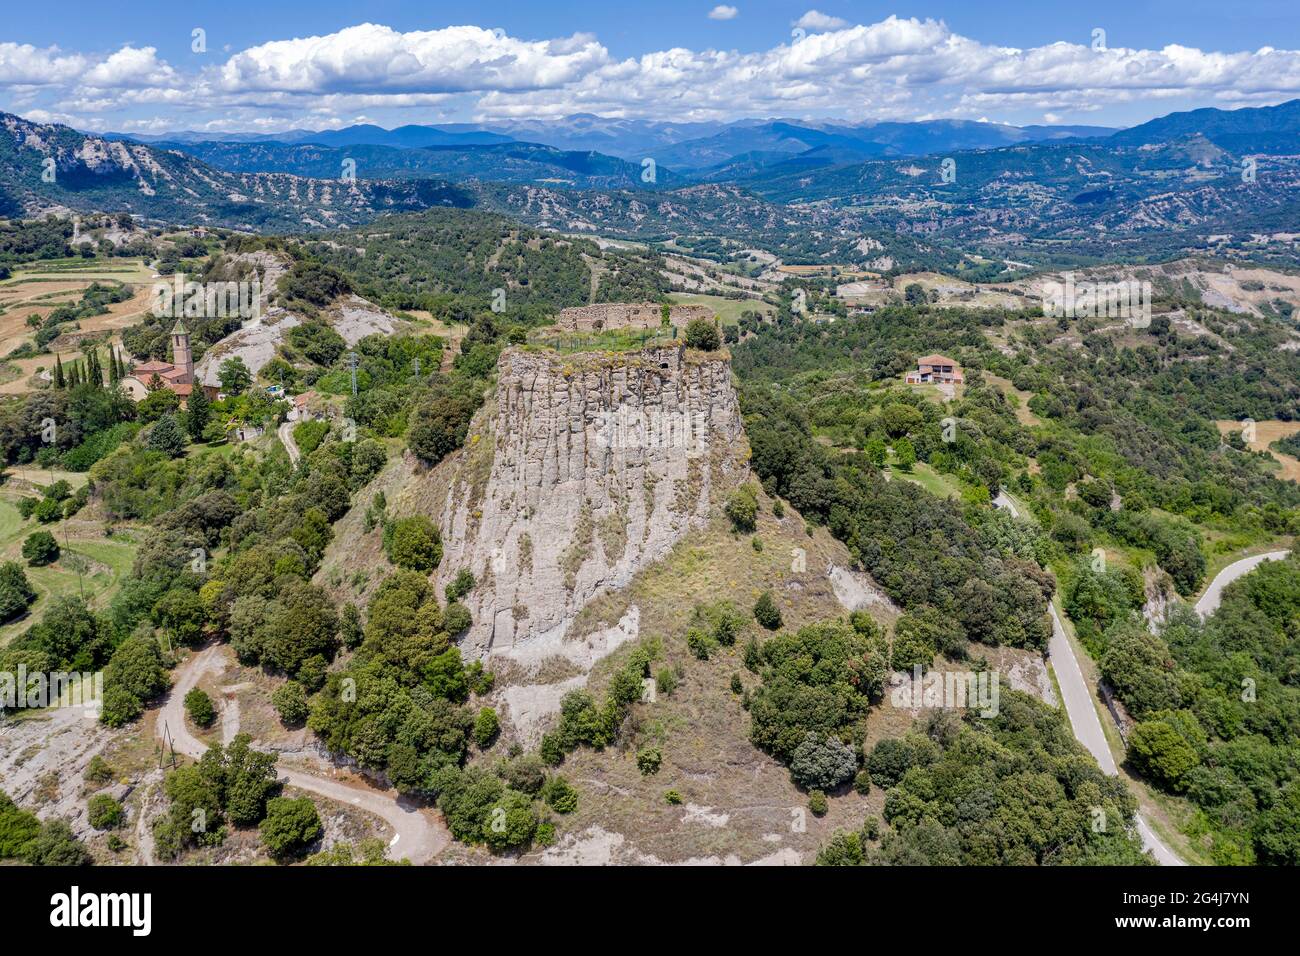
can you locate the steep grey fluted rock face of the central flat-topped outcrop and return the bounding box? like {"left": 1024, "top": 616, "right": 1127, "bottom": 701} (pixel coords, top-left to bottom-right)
{"left": 434, "top": 347, "right": 749, "bottom": 672}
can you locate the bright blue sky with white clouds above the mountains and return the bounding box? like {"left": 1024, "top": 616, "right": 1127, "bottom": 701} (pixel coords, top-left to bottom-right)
{"left": 0, "top": 0, "right": 1300, "bottom": 134}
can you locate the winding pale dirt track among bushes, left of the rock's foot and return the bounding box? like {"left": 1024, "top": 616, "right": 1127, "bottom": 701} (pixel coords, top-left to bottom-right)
{"left": 157, "top": 644, "right": 451, "bottom": 864}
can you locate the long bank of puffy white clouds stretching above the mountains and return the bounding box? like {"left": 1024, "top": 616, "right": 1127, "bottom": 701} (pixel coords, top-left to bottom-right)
{"left": 0, "top": 16, "right": 1300, "bottom": 129}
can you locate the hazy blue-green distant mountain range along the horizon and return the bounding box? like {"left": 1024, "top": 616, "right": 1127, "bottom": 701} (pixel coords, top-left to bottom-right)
{"left": 0, "top": 100, "right": 1300, "bottom": 269}
